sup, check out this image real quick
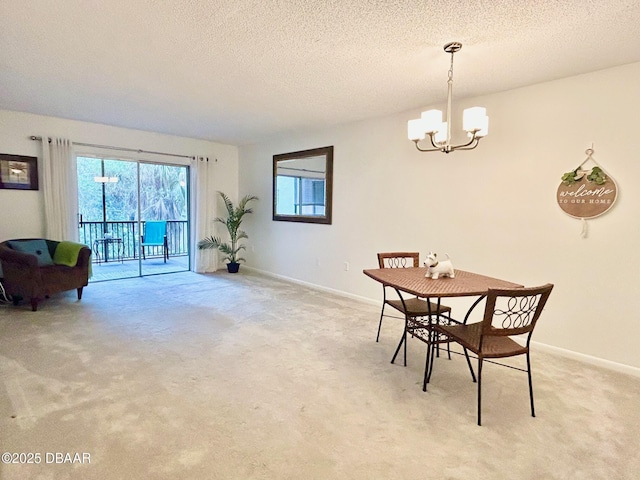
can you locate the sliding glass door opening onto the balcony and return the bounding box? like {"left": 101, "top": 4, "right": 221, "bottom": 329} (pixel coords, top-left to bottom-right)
{"left": 77, "top": 156, "right": 189, "bottom": 281}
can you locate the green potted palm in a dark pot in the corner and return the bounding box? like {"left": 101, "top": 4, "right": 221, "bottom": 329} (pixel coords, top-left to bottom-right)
{"left": 198, "top": 192, "right": 258, "bottom": 273}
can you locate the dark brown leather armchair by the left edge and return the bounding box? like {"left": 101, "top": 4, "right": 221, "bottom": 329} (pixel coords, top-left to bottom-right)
{"left": 0, "top": 239, "right": 91, "bottom": 312}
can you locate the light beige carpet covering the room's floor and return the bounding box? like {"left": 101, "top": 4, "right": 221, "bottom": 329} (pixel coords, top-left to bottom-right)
{"left": 0, "top": 271, "right": 640, "bottom": 480}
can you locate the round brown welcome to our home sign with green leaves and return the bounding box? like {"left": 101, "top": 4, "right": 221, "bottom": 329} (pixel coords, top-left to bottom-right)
{"left": 557, "top": 167, "right": 618, "bottom": 218}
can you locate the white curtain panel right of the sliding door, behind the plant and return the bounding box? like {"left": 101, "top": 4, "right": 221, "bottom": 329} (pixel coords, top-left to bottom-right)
{"left": 191, "top": 157, "right": 218, "bottom": 273}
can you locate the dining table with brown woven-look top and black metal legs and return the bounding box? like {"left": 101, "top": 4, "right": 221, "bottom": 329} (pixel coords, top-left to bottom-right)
{"left": 363, "top": 267, "right": 524, "bottom": 391}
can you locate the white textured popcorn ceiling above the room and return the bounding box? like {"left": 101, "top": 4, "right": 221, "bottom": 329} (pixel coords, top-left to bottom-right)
{"left": 0, "top": 0, "right": 640, "bottom": 145}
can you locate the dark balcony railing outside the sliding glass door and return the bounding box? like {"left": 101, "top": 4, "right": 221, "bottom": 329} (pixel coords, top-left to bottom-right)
{"left": 79, "top": 220, "right": 189, "bottom": 262}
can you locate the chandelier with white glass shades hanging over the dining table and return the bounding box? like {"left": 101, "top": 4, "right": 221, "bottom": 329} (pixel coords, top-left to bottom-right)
{"left": 408, "top": 42, "right": 489, "bottom": 153}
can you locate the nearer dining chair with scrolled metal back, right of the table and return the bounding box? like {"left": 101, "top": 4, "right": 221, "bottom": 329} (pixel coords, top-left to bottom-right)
{"left": 434, "top": 284, "right": 553, "bottom": 425}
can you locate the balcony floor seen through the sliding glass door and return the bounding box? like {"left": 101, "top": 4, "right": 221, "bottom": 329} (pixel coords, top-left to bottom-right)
{"left": 89, "top": 255, "right": 189, "bottom": 282}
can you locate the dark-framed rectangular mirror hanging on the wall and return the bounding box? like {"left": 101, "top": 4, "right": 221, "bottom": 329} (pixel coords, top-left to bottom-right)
{"left": 273, "top": 146, "right": 333, "bottom": 225}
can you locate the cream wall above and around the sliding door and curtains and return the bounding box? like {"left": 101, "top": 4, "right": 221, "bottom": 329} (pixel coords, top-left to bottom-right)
{"left": 0, "top": 110, "right": 238, "bottom": 241}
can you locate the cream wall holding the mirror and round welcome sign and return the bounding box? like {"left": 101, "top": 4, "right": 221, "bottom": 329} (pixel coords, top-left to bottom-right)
{"left": 239, "top": 64, "right": 640, "bottom": 369}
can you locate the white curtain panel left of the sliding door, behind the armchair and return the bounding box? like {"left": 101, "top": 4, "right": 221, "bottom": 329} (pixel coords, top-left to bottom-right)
{"left": 42, "top": 135, "right": 78, "bottom": 241}
